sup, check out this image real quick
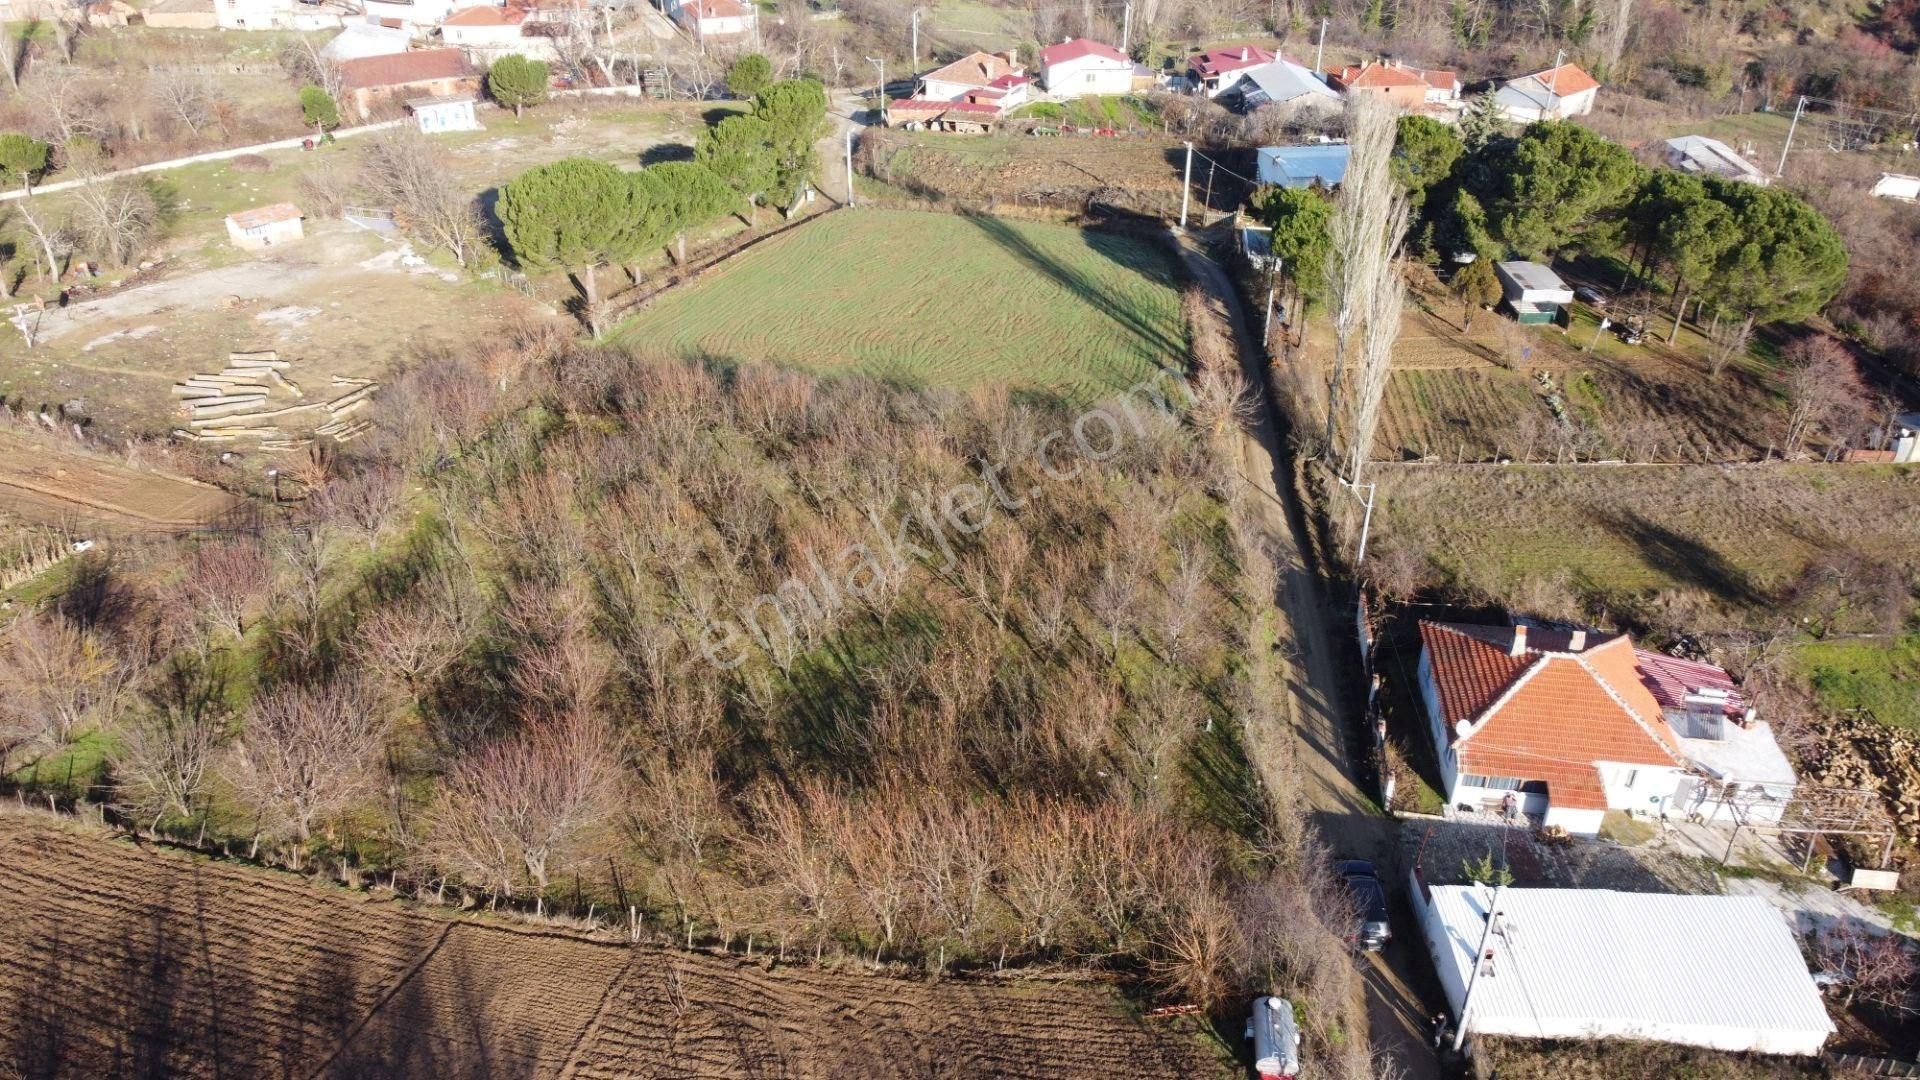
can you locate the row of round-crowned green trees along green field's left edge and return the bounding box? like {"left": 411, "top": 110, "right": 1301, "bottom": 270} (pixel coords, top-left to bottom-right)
{"left": 499, "top": 79, "right": 826, "bottom": 336}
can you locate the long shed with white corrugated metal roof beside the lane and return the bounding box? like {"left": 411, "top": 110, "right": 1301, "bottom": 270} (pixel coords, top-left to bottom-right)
{"left": 1415, "top": 886, "right": 1834, "bottom": 1055}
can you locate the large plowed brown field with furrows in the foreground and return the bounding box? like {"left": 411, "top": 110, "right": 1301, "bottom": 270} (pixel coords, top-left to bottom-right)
{"left": 0, "top": 811, "right": 1223, "bottom": 1080}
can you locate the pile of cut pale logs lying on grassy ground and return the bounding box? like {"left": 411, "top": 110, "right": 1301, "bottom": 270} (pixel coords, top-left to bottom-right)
{"left": 173, "top": 350, "right": 380, "bottom": 450}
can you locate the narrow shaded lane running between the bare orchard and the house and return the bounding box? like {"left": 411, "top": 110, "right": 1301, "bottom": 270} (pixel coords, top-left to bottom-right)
{"left": 1183, "top": 231, "right": 1440, "bottom": 1080}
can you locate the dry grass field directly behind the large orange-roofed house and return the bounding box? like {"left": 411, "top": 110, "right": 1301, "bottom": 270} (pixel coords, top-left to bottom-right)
{"left": 1375, "top": 457, "right": 1920, "bottom": 628}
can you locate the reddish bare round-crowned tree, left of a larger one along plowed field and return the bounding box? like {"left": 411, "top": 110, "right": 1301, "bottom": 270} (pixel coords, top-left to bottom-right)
{"left": 223, "top": 676, "right": 388, "bottom": 857}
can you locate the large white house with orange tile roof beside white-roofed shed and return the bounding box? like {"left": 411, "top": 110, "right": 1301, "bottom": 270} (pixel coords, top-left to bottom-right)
{"left": 1419, "top": 621, "right": 1793, "bottom": 836}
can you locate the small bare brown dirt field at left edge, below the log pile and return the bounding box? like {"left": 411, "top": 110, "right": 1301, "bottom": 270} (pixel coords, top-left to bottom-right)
{"left": 0, "top": 434, "right": 238, "bottom": 532}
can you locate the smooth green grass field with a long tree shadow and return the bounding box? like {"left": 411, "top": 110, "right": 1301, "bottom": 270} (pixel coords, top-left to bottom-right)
{"left": 616, "top": 209, "right": 1187, "bottom": 402}
